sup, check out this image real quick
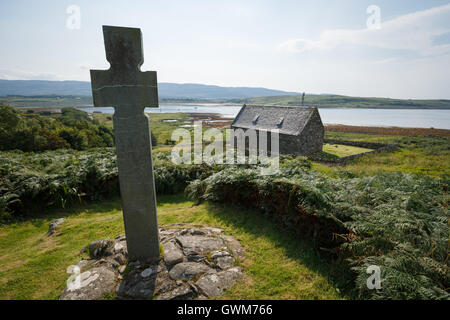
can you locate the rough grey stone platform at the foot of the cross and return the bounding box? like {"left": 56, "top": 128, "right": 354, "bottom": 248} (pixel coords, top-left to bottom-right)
{"left": 60, "top": 224, "right": 244, "bottom": 300}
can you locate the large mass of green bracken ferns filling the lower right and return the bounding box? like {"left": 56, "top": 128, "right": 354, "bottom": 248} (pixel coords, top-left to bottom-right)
{"left": 186, "top": 161, "right": 450, "bottom": 299}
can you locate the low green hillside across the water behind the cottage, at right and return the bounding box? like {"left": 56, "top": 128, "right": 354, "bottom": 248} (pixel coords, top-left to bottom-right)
{"left": 228, "top": 94, "right": 450, "bottom": 109}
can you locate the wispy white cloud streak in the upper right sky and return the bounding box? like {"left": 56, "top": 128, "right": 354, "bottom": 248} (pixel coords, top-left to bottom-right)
{"left": 279, "top": 4, "right": 450, "bottom": 56}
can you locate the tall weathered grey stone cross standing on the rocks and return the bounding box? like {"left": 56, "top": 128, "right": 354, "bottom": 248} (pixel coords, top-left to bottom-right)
{"left": 91, "top": 26, "right": 160, "bottom": 261}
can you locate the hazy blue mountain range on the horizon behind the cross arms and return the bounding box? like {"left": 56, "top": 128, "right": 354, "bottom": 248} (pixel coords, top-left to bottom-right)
{"left": 0, "top": 80, "right": 298, "bottom": 99}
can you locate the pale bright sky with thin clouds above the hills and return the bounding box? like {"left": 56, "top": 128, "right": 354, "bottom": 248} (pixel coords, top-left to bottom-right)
{"left": 0, "top": 0, "right": 450, "bottom": 99}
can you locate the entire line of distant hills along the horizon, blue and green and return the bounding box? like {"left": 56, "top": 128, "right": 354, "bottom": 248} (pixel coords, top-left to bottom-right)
{"left": 0, "top": 80, "right": 450, "bottom": 109}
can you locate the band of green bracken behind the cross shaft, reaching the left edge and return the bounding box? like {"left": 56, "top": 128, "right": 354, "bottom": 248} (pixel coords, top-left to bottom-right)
{"left": 0, "top": 148, "right": 214, "bottom": 221}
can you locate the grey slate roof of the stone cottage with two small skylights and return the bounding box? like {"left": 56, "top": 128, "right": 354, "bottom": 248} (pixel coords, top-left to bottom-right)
{"left": 231, "top": 105, "right": 318, "bottom": 135}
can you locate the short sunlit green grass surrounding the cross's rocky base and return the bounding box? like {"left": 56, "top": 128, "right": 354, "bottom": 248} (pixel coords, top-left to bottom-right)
{"left": 0, "top": 195, "right": 346, "bottom": 299}
